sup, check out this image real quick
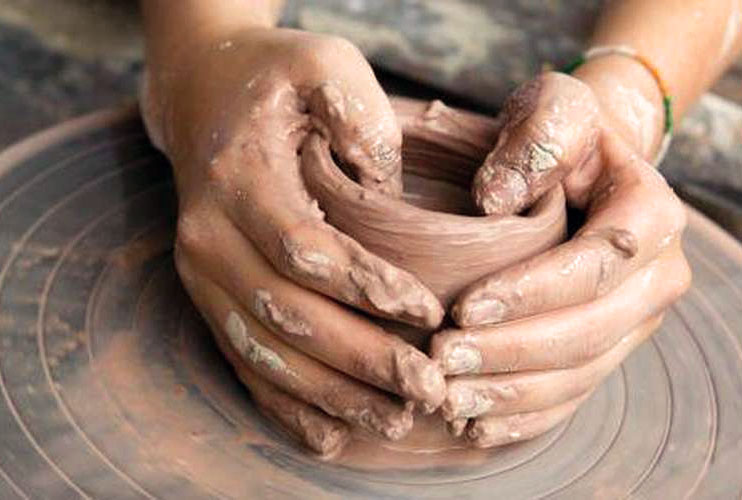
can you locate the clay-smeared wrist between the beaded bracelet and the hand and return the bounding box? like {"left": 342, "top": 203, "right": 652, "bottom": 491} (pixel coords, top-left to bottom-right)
{"left": 574, "top": 55, "right": 665, "bottom": 161}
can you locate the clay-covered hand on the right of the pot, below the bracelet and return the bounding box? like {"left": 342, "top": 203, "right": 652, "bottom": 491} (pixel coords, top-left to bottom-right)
{"left": 431, "top": 73, "right": 690, "bottom": 447}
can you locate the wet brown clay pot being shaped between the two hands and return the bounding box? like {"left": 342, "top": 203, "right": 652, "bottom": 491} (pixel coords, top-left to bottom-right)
{"left": 302, "top": 98, "right": 566, "bottom": 308}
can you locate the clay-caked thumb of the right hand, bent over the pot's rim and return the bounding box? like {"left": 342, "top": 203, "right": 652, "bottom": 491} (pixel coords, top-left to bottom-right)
{"left": 472, "top": 73, "right": 599, "bottom": 215}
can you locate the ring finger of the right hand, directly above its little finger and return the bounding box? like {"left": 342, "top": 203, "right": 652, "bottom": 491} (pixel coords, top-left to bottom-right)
{"left": 441, "top": 316, "right": 661, "bottom": 420}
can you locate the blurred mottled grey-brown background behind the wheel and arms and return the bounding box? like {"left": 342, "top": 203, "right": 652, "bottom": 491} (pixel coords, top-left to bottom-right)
{"left": 0, "top": 0, "right": 742, "bottom": 239}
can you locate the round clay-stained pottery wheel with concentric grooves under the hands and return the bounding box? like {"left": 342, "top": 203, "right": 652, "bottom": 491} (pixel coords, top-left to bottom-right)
{"left": 0, "top": 103, "right": 742, "bottom": 499}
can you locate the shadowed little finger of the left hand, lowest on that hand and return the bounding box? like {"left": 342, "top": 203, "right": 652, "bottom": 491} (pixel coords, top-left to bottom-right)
{"left": 235, "top": 364, "right": 350, "bottom": 459}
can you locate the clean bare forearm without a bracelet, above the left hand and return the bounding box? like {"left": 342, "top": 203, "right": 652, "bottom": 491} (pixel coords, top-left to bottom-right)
{"left": 141, "top": 0, "right": 284, "bottom": 71}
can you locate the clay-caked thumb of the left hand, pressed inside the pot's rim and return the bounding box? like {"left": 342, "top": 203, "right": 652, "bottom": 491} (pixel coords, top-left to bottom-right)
{"left": 308, "top": 77, "right": 402, "bottom": 198}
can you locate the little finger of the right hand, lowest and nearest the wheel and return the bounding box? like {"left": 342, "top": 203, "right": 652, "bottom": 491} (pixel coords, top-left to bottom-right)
{"left": 466, "top": 393, "right": 590, "bottom": 448}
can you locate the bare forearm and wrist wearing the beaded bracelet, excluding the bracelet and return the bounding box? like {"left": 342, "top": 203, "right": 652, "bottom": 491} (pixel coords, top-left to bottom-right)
{"left": 576, "top": 0, "right": 742, "bottom": 156}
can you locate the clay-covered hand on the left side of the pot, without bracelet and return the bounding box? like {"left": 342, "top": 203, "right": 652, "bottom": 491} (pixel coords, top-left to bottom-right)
{"left": 143, "top": 28, "right": 444, "bottom": 454}
